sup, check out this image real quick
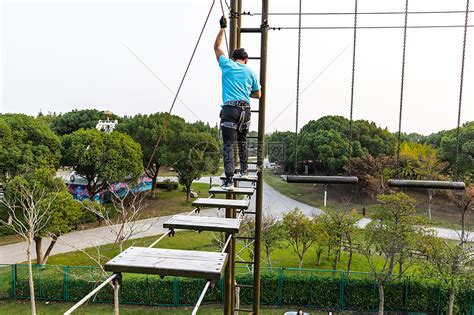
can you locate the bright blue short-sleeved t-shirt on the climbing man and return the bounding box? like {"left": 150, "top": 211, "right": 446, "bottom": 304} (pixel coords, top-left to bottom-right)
{"left": 219, "top": 55, "right": 260, "bottom": 104}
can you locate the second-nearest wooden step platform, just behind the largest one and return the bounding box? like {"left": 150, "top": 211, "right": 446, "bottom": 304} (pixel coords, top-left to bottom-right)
{"left": 163, "top": 215, "right": 241, "bottom": 233}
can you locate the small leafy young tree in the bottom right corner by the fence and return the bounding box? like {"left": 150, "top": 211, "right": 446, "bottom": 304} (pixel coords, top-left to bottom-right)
{"left": 428, "top": 238, "right": 474, "bottom": 315}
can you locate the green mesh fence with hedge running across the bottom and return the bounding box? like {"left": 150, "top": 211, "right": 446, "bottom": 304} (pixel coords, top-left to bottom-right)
{"left": 0, "top": 264, "right": 474, "bottom": 315}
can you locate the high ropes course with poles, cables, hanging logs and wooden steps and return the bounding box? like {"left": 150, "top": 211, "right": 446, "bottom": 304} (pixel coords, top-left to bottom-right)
{"left": 64, "top": 0, "right": 472, "bottom": 315}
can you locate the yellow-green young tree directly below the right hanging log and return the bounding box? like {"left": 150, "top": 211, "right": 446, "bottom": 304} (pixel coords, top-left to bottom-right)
{"left": 363, "top": 193, "right": 431, "bottom": 315}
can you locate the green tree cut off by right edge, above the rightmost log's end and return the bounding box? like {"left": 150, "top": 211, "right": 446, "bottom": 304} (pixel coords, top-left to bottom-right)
{"left": 440, "top": 121, "right": 474, "bottom": 183}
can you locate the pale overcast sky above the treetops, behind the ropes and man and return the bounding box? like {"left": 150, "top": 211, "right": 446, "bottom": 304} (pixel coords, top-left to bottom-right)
{"left": 0, "top": 0, "right": 474, "bottom": 134}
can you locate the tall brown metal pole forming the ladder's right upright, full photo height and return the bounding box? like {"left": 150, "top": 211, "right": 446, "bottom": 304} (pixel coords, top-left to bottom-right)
{"left": 253, "top": 0, "right": 268, "bottom": 315}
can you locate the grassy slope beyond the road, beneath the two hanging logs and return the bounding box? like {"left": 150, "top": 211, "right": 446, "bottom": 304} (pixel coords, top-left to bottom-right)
{"left": 264, "top": 172, "right": 468, "bottom": 229}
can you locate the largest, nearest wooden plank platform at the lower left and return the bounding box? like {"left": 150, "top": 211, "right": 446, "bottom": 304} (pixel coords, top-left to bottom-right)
{"left": 105, "top": 247, "right": 227, "bottom": 280}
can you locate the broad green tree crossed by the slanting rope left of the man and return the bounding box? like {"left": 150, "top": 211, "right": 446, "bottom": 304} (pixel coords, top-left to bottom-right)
{"left": 116, "top": 113, "right": 187, "bottom": 189}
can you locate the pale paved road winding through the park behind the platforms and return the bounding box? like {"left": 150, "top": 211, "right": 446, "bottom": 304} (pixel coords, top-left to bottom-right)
{"left": 0, "top": 177, "right": 474, "bottom": 264}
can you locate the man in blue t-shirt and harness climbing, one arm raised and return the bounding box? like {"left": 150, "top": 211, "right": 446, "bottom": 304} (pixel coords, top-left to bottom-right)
{"left": 214, "top": 17, "right": 261, "bottom": 190}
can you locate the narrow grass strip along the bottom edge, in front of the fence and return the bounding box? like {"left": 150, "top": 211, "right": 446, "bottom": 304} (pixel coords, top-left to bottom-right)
{"left": 0, "top": 301, "right": 318, "bottom": 315}
